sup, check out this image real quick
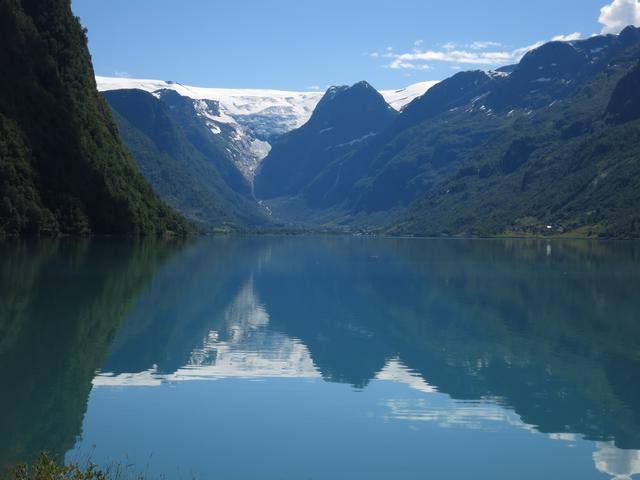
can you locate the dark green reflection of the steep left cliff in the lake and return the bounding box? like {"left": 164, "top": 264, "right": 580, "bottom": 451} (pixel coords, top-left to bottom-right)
{"left": 0, "top": 240, "right": 189, "bottom": 473}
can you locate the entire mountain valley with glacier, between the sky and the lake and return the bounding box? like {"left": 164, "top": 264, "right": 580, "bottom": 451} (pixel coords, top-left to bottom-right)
{"left": 0, "top": 0, "right": 640, "bottom": 238}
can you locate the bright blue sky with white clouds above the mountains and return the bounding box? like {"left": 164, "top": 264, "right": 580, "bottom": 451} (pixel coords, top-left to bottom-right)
{"left": 73, "top": 0, "right": 640, "bottom": 90}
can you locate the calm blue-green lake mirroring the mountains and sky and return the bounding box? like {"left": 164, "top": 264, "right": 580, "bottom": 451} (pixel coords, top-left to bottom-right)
{"left": 0, "top": 237, "right": 640, "bottom": 480}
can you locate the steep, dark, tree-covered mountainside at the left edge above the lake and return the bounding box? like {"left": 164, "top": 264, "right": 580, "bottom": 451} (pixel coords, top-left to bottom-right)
{"left": 0, "top": 0, "right": 191, "bottom": 234}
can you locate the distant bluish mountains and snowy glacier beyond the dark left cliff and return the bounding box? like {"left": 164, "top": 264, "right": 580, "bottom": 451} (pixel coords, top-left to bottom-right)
{"left": 97, "top": 27, "right": 640, "bottom": 237}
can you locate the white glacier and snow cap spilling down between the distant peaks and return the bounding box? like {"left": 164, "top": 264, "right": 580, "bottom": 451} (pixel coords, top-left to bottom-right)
{"left": 96, "top": 76, "right": 437, "bottom": 181}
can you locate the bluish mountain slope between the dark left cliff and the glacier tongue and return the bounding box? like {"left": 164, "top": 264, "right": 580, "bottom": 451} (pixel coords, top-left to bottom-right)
{"left": 103, "top": 90, "right": 267, "bottom": 230}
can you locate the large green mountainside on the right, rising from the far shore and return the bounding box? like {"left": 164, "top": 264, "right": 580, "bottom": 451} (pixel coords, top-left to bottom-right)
{"left": 392, "top": 27, "right": 640, "bottom": 237}
